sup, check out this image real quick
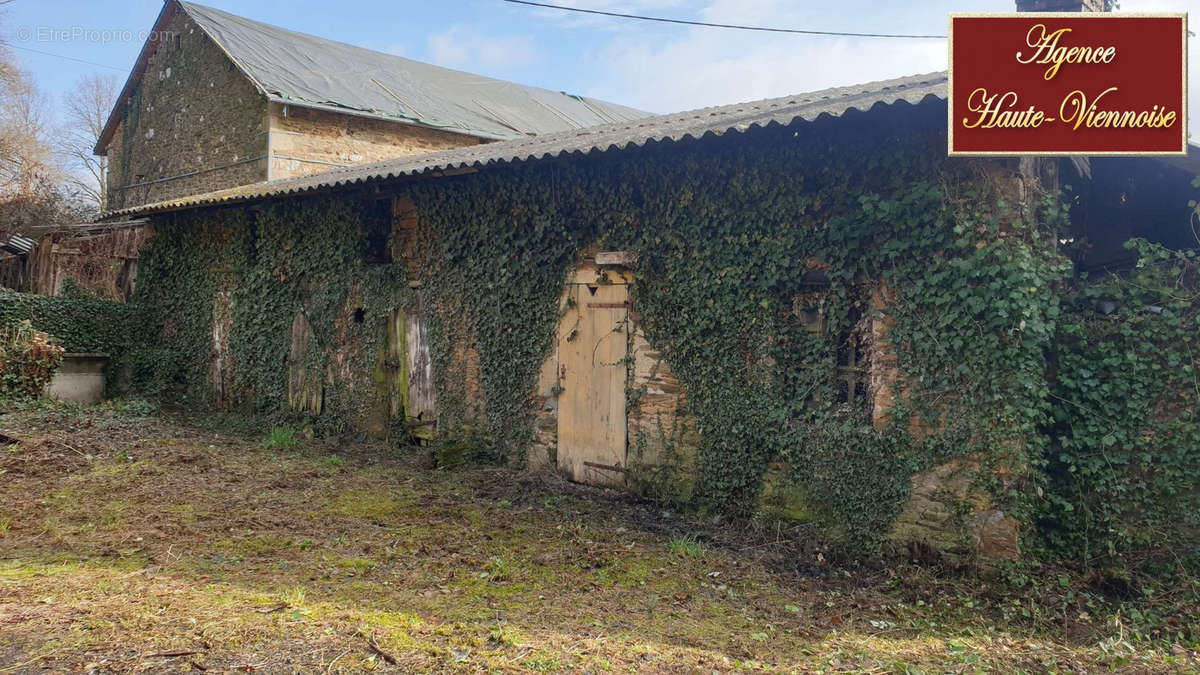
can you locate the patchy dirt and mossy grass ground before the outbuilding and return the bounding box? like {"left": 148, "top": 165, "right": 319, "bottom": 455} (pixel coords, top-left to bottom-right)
{"left": 0, "top": 405, "right": 1200, "bottom": 673}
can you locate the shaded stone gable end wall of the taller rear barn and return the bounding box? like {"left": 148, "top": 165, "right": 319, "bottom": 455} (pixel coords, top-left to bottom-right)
{"left": 107, "top": 5, "right": 268, "bottom": 209}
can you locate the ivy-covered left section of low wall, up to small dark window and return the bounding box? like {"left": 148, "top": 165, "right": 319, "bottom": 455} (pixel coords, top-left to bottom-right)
{"left": 136, "top": 196, "right": 416, "bottom": 432}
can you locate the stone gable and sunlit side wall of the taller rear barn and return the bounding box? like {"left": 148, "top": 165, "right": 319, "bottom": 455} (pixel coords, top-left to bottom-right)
{"left": 106, "top": 6, "right": 482, "bottom": 209}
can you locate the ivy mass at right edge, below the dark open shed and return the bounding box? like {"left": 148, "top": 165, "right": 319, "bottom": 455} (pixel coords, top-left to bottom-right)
{"left": 1038, "top": 240, "right": 1200, "bottom": 571}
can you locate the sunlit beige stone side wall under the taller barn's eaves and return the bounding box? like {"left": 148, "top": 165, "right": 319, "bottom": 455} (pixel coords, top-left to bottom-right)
{"left": 270, "top": 103, "right": 481, "bottom": 180}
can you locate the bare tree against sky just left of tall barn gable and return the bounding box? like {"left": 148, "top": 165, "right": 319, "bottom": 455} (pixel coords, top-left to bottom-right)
{"left": 58, "top": 73, "right": 120, "bottom": 211}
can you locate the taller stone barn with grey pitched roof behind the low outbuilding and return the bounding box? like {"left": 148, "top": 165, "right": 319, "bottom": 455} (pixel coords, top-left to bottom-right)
{"left": 96, "top": 0, "right": 647, "bottom": 209}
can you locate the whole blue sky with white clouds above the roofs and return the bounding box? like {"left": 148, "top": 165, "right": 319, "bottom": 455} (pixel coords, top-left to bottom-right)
{"left": 0, "top": 0, "right": 1200, "bottom": 127}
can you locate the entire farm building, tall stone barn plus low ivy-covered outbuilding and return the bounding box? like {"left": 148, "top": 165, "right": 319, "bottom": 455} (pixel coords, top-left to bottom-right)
{"left": 75, "top": 1, "right": 1200, "bottom": 557}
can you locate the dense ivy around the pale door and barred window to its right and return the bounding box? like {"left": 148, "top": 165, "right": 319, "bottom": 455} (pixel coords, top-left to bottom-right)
{"left": 414, "top": 107, "right": 1066, "bottom": 546}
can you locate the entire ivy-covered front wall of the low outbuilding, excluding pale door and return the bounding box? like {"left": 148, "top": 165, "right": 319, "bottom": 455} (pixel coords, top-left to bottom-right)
{"left": 131, "top": 97, "right": 1195, "bottom": 564}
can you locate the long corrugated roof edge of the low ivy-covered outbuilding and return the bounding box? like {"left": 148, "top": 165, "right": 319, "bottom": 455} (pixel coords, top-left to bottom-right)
{"left": 106, "top": 72, "right": 947, "bottom": 217}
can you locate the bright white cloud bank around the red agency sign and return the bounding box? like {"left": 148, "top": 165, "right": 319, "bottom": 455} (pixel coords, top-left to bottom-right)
{"left": 588, "top": 0, "right": 1200, "bottom": 138}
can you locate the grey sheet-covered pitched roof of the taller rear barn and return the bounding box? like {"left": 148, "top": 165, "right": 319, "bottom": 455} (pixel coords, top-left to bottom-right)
{"left": 96, "top": 0, "right": 650, "bottom": 151}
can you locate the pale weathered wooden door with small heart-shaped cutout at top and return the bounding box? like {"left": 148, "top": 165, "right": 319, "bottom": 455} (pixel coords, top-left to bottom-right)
{"left": 558, "top": 283, "right": 629, "bottom": 485}
